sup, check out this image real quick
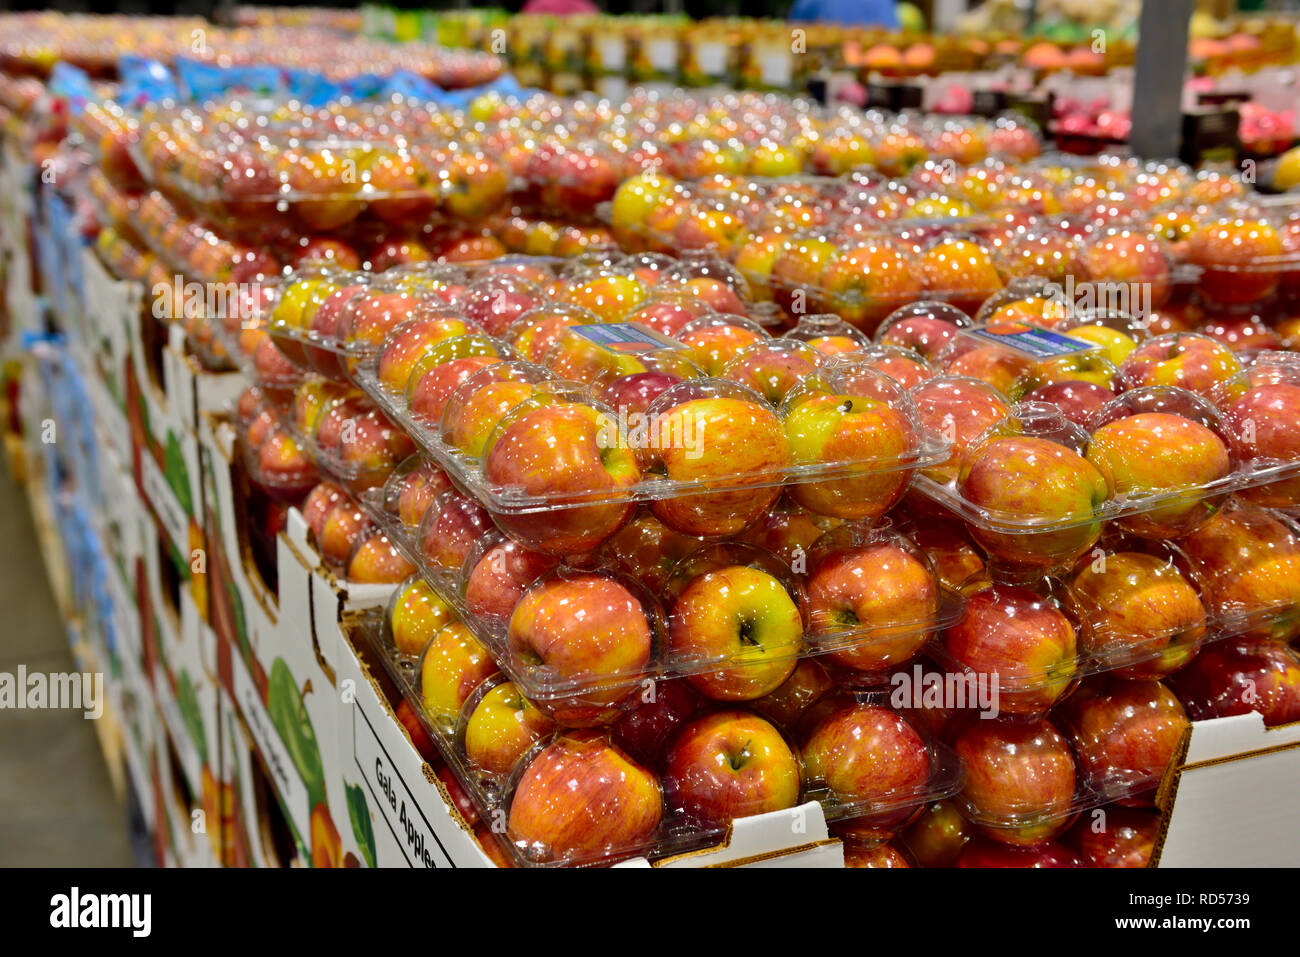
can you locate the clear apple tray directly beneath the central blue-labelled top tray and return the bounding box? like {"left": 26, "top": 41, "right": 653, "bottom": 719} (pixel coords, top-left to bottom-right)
{"left": 361, "top": 460, "right": 962, "bottom": 696}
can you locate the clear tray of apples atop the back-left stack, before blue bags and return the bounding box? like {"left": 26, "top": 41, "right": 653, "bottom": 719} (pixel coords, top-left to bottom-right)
{"left": 131, "top": 103, "right": 510, "bottom": 231}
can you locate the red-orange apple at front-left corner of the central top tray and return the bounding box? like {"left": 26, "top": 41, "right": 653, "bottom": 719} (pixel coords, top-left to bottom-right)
{"left": 484, "top": 400, "right": 641, "bottom": 555}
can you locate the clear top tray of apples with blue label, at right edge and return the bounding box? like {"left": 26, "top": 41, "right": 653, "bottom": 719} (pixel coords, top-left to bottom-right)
{"left": 911, "top": 343, "right": 1300, "bottom": 568}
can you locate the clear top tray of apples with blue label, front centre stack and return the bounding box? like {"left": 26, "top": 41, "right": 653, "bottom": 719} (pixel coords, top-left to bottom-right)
{"left": 343, "top": 267, "right": 946, "bottom": 527}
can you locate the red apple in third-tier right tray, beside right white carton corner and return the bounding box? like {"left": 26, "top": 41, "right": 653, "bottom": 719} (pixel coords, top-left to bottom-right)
{"left": 1062, "top": 676, "right": 1191, "bottom": 805}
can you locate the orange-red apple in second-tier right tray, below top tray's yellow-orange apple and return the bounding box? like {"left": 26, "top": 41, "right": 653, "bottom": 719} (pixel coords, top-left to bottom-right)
{"left": 1063, "top": 551, "right": 1206, "bottom": 679}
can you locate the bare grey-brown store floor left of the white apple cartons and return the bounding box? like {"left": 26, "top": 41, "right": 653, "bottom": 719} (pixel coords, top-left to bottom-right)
{"left": 0, "top": 468, "right": 135, "bottom": 867}
